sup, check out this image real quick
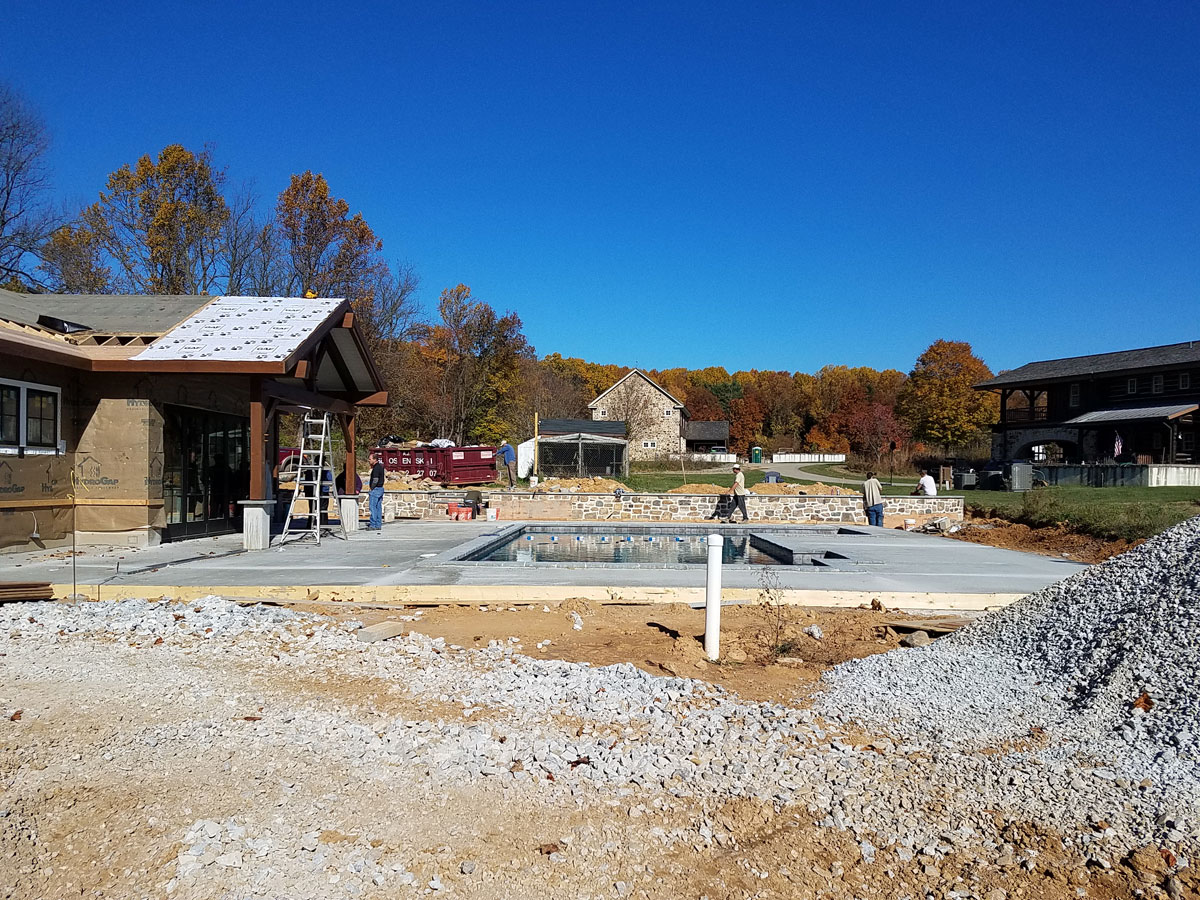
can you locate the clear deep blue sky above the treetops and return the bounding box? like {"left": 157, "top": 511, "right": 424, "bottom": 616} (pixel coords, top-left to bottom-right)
{"left": 0, "top": 0, "right": 1200, "bottom": 371}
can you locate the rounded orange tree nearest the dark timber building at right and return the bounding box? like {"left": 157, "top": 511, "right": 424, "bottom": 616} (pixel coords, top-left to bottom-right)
{"left": 899, "top": 341, "right": 998, "bottom": 451}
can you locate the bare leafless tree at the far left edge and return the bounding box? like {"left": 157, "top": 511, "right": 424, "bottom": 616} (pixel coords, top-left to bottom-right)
{"left": 0, "top": 84, "right": 58, "bottom": 283}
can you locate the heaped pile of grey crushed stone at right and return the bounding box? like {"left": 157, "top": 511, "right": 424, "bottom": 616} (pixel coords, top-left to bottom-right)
{"left": 820, "top": 517, "right": 1200, "bottom": 793}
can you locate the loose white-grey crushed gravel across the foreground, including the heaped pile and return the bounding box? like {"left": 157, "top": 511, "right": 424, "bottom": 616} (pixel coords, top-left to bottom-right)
{"left": 0, "top": 561, "right": 1200, "bottom": 896}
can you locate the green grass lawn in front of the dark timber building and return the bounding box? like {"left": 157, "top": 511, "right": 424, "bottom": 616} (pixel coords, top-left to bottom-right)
{"left": 961, "top": 487, "right": 1200, "bottom": 540}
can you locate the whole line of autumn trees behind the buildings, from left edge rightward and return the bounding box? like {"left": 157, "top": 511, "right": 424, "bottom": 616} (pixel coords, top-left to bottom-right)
{"left": 0, "top": 85, "right": 996, "bottom": 460}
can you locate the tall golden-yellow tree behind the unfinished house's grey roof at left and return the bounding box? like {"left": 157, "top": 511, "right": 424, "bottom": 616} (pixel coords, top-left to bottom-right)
{"left": 80, "top": 144, "right": 229, "bottom": 294}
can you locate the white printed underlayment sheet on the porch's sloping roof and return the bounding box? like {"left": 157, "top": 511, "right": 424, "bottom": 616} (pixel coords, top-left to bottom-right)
{"left": 133, "top": 296, "right": 344, "bottom": 362}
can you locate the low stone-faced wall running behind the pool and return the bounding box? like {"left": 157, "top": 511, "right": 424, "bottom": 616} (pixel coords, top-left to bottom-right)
{"left": 369, "top": 491, "right": 962, "bottom": 524}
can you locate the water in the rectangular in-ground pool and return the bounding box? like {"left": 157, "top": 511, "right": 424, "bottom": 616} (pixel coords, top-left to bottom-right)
{"left": 466, "top": 527, "right": 782, "bottom": 565}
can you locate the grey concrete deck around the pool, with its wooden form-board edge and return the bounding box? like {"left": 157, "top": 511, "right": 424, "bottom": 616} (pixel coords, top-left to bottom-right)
{"left": 0, "top": 520, "right": 1086, "bottom": 610}
